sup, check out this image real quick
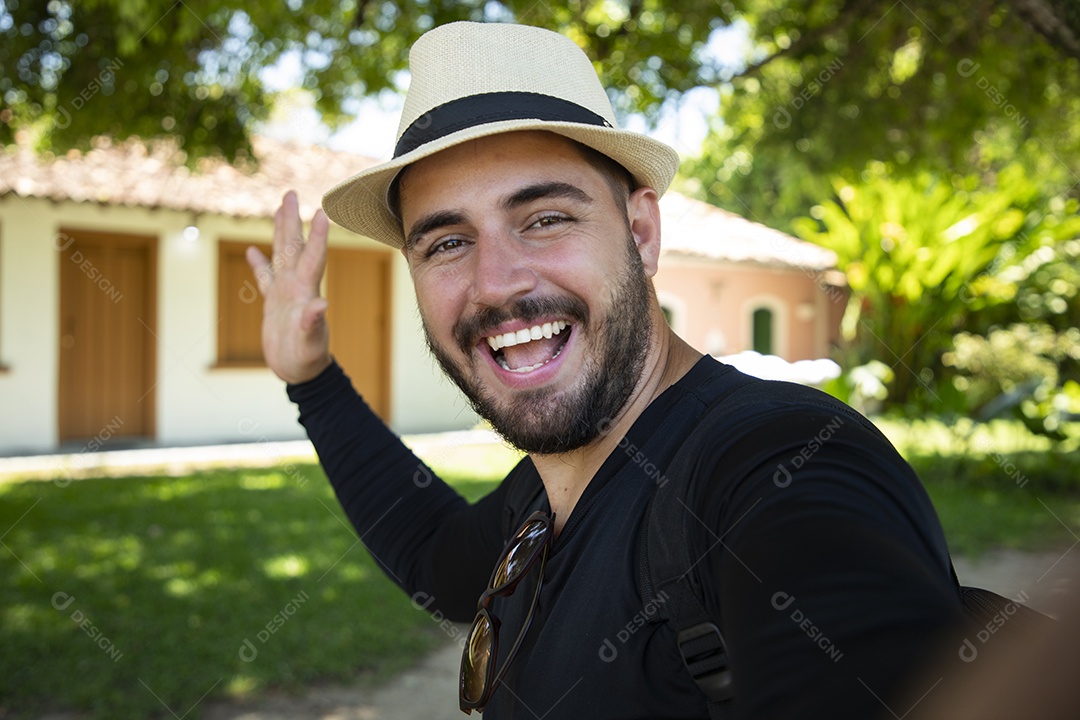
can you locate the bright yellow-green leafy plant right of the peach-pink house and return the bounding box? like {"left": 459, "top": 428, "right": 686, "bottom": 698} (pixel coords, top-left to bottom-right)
{"left": 795, "top": 166, "right": 1072, "bottom": 406}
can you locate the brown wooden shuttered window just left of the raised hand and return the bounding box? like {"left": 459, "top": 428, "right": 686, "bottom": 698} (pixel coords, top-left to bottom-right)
{"left": 217, "top": 241, "right": 271, "bottom": 367}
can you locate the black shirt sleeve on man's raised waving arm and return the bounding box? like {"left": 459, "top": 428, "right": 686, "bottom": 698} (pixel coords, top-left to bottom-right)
{"left": 287, "top": 363, "right": 505, "bottom": 622}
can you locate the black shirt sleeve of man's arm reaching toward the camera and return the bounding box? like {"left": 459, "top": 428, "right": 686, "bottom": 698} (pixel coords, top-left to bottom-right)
{"left": 699, "top": 410, "right": 961, "bottom": 720}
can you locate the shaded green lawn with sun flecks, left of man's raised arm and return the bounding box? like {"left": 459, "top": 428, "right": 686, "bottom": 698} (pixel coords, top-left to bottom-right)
{"left": 0, "top": 466, "right": 491, "bottom": 719}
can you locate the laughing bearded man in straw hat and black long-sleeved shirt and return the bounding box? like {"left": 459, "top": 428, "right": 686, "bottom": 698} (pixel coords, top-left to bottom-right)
{"left": 248, "top": 23, "right": 960, "bottom": 718}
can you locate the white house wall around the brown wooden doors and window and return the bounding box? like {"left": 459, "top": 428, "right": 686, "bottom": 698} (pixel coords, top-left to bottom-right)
{"left": 0, "top": 195, "right": 475, "bottom": 454}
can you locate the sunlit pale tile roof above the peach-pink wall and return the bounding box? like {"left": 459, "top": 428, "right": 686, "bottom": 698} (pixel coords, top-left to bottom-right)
{"left": 660, "top": 192, "right": 836, "bottom": 271}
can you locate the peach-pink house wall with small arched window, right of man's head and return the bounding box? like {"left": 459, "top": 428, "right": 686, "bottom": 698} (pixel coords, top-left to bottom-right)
{"left": 653, "top": 255, "right": 842, "bottom": 362}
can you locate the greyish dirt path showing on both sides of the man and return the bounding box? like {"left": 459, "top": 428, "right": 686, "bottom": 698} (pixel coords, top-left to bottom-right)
{"left": 192, "top": 546, "right": 1080, "bottom": 720}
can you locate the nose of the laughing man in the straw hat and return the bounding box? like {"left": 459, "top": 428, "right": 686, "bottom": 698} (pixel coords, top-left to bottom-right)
{"left": 470, "top": 232, "right": 539, "bottom": 308}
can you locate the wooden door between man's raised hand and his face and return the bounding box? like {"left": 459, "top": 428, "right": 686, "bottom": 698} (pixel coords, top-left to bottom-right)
{"left": 326, "top": 247, "right": 391, "bottom": 421}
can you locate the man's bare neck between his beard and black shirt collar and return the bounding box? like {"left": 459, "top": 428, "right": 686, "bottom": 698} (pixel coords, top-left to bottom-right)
{"left": 531, "top": 326, "right": 701, "bottom": 533}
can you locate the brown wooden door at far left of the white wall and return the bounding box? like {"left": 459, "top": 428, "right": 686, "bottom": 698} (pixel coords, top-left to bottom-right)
{"left": 56, "top": 230, "right": 157, "bottom": 449}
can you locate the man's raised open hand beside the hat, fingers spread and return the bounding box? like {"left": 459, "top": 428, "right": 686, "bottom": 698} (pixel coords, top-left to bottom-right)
{"left": 246, "top": 190, "right": 330, "bottom": 383}
